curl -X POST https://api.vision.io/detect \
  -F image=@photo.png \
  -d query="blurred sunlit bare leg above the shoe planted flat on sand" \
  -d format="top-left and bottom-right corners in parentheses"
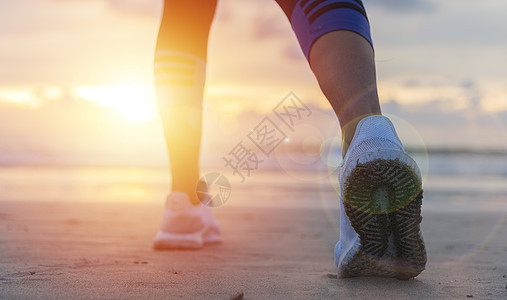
top-left (154, 0), bottom-right (217, 204)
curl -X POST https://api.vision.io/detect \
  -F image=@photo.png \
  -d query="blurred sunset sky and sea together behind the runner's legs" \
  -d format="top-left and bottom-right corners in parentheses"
top-left (0, 0), bottom-right (507, 204)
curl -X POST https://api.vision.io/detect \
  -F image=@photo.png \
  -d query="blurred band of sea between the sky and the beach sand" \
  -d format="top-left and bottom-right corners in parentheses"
top-left (0, 150), bottom-right (507, 211)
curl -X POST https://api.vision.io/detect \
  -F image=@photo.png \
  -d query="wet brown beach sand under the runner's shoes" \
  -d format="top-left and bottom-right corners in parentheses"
top-left (0, 192), bottom-right (507, 299)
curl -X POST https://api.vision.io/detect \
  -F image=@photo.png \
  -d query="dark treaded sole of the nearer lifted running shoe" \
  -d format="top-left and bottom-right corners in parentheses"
top-left (342, 150), bottom-right (426, 279)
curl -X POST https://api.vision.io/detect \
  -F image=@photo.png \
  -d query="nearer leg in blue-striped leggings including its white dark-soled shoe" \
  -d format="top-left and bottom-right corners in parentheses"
top-left (278, 0), bottom-right (426, 279)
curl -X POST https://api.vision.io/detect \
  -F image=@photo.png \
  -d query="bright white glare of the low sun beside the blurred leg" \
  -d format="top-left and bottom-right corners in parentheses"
top-left (75, 85), bottom-right (156, 122)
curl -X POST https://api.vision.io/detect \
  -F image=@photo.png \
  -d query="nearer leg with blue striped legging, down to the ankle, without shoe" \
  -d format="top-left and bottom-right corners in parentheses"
top-left (277, 0), bottom-right (381, 155)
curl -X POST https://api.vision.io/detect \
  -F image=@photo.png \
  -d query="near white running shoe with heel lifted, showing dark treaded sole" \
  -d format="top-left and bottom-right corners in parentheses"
top-left (335, 115), bottom-right (426, 279)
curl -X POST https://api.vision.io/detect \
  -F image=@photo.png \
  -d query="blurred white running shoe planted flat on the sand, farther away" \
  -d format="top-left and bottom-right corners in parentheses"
top-left (153, 192), bottom-right (221, 249)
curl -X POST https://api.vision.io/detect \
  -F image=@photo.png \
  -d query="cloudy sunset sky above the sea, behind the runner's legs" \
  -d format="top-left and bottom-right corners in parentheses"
top-left (0, 0), bottom-right (507, 165)
